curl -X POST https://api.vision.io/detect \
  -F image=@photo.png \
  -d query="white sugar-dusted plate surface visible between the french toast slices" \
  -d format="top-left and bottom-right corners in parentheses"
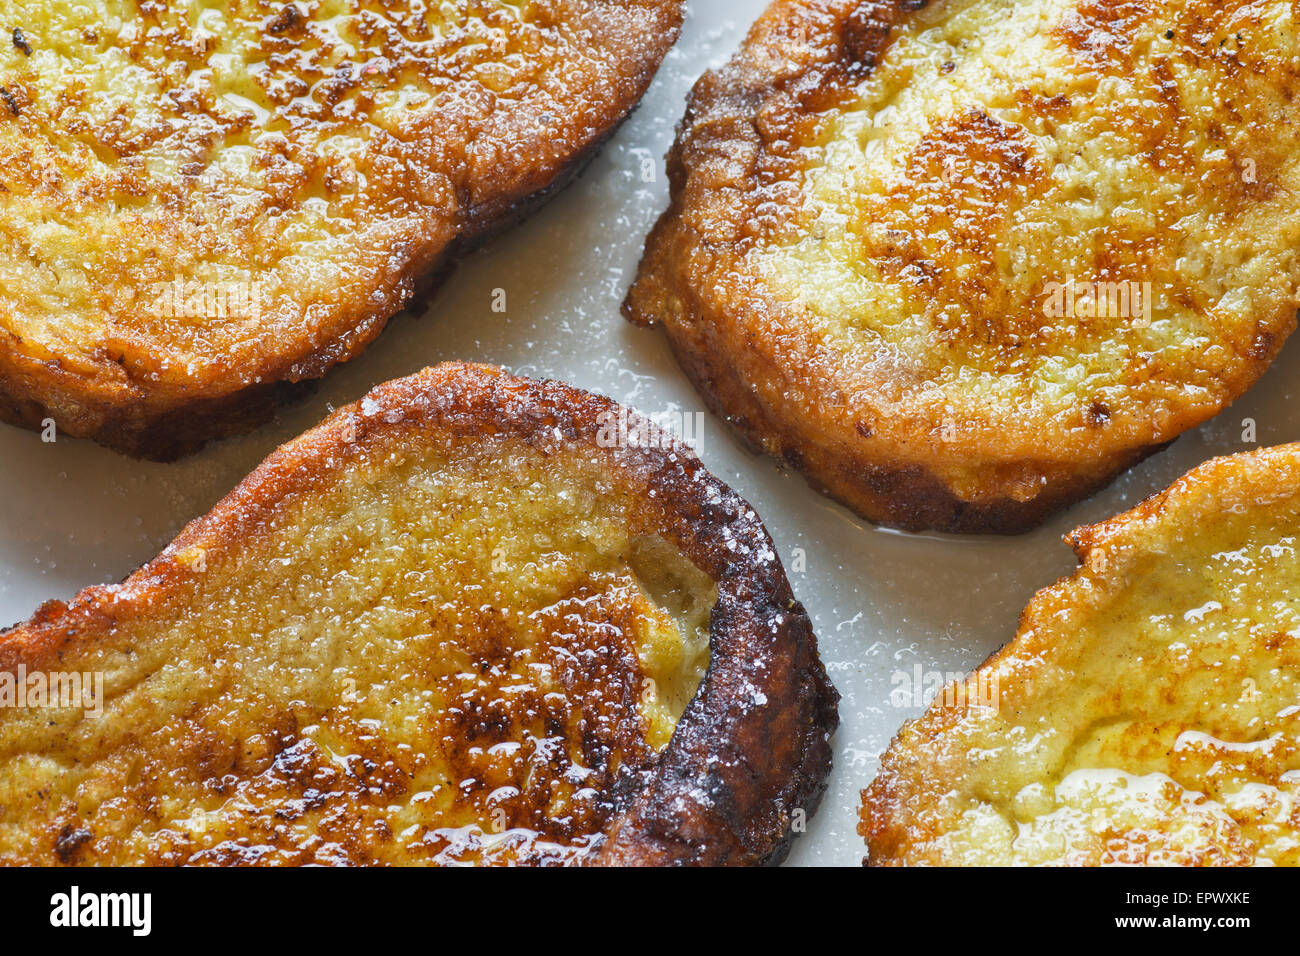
top-left (0, 0), bottom-right (1300, 865)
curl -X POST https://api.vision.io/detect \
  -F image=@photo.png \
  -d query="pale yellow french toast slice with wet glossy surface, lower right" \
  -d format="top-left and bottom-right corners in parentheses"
top-left (861, 445), bottom-right (1300, 865)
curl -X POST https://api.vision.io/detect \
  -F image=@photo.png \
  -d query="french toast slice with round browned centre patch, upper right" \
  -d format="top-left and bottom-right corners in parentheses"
top-left (625, 0), bottom-right (1300, 532)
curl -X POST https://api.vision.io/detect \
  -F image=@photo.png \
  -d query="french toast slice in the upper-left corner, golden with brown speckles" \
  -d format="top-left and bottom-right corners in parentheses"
top-left (0, 0), bottom-right (683, 459)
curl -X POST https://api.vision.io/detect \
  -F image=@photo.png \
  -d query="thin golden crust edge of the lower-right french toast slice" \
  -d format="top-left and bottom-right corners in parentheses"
top-left (858, 442), bottom-right (1300, 866)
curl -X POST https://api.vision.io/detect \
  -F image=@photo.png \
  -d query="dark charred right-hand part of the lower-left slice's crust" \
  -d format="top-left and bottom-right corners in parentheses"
top-left (372, 364), bottom-right (839, 865)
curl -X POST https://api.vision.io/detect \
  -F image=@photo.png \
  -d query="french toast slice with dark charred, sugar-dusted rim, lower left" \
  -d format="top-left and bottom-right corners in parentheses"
top-left (0, 364), bottom-right (837, 865)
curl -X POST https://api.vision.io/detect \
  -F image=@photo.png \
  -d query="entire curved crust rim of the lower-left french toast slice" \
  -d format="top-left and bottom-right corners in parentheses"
top-left (0, 363), bottom-right (839, 865)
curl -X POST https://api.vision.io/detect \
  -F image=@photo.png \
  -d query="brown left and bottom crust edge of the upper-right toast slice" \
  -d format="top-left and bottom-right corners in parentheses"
top-left (623, 0), bottom-right (1295, 535)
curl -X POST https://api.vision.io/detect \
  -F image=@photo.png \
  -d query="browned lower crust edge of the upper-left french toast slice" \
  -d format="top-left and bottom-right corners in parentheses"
top-left (0, 0), bottom-right (683, 462)
